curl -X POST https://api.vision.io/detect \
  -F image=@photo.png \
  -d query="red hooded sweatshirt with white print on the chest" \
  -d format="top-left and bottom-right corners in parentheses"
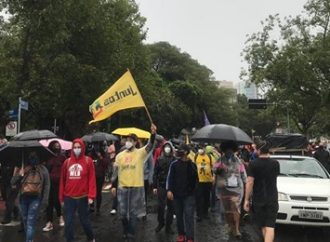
top-left (59, 139), bottom-right (96, 202)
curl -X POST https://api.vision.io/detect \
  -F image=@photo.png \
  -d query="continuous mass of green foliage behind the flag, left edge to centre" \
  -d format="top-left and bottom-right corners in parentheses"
top-left (0, 0), bottom-right (237, 138)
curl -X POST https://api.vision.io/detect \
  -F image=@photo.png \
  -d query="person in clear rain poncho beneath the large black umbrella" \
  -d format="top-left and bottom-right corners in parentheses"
top-left (214, 141), bottom-right (246, 238)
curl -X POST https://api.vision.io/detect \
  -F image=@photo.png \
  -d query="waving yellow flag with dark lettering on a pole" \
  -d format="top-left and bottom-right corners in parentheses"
top-left (89, 71), bottom-right (145, 124)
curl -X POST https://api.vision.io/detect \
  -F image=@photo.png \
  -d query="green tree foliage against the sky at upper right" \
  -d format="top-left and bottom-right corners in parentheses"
top-left (243, 0), bottom-right (330, 135)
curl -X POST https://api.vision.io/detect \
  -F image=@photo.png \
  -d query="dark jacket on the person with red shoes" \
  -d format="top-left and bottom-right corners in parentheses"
top-left (166, 159), bottom-right (198, 198)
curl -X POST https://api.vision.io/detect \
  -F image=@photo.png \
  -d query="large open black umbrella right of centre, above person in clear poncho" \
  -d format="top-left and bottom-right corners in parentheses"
top-left (192, 124), bottom-right (253, 144)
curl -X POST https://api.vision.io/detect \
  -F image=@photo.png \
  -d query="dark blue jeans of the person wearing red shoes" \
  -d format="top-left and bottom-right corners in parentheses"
top-left (174, 196), bottom-right (195, 240)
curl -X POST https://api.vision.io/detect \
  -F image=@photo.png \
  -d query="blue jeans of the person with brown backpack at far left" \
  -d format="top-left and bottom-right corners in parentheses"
top-left (19, 195), bottom-right (41, 242)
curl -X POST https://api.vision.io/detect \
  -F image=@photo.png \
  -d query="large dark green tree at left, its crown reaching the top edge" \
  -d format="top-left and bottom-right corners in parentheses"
top-left (0, 0), bottom-right (147, 137)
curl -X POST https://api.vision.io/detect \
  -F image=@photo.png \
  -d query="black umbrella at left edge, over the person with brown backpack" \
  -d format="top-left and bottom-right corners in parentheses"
top-left (0, 140), bottom-right (55, 164)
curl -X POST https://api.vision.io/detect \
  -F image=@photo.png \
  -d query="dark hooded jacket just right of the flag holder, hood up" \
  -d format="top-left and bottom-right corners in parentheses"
top-left (153, 142), bottom-right (176, 188)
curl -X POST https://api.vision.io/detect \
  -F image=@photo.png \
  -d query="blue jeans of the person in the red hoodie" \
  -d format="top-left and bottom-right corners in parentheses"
top-left (64, 197), bottom-right (94, 242)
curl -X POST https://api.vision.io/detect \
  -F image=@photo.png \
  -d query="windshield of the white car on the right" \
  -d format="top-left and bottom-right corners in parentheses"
top-left (275, 158), bottom-right (328, 178)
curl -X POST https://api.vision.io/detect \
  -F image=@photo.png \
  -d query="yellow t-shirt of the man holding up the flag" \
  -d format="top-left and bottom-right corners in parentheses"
top-left (114, 147), bottom-right (148, 187)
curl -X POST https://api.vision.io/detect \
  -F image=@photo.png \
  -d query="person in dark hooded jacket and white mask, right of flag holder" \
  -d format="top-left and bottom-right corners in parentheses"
top-left (153, 142), bottom-right (176, 233)
